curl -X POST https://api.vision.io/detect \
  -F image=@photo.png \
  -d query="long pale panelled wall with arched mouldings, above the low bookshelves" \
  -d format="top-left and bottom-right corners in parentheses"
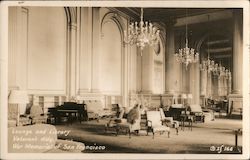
top-left (9, 7), bottom-right (164, 107)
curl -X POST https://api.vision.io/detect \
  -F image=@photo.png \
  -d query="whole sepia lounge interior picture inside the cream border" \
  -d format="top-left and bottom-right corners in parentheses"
top-left (1, 1), bottom-right (249, 158)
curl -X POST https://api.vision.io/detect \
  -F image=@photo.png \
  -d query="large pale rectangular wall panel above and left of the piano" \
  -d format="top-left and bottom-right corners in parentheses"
top-left (27, 7), bottom-right (67, 93)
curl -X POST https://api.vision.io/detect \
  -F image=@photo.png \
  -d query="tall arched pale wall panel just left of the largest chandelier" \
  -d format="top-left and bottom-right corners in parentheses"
top-left (100, 20), bottom-right (122, 95)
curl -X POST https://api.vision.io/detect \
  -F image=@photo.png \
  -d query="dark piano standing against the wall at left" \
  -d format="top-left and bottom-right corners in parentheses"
top-left (48, 102), bottom-right (87, 124)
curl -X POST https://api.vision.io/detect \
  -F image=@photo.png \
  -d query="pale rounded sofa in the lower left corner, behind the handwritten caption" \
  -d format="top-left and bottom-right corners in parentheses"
top-left (8, 124), bottom-right (85, 153)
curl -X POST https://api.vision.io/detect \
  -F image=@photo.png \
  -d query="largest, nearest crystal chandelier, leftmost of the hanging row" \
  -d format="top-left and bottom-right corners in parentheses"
top-left (124, 8), bottom-right (160, 56)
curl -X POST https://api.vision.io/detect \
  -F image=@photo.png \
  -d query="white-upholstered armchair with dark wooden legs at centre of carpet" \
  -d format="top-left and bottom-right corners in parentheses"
top-left (146, 111), bottom-right (170, 138)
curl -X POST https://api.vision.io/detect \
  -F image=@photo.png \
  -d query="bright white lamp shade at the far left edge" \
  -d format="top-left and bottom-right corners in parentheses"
top-left (9, 90), bottom-right (29, 104)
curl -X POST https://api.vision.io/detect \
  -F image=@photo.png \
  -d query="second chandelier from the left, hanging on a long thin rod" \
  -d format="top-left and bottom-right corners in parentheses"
top-left (175, 9), bottom-right (199, 69)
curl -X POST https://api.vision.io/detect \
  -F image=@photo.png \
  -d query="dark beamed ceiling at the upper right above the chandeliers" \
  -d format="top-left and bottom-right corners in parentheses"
top-left (116, 7), bottom-right (236, 68)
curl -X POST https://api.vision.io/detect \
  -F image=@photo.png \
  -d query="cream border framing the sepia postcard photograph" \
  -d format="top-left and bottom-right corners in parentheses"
top-left (0, 0), bottom-right (250, 159)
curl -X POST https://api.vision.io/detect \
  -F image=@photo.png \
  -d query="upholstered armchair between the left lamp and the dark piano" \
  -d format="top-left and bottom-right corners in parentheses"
top-left (30, 105), bottom-right (48, 124)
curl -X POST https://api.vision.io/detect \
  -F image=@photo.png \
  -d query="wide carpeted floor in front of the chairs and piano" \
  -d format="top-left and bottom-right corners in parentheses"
top-left (56, 119), bottom-right (242, 154)
